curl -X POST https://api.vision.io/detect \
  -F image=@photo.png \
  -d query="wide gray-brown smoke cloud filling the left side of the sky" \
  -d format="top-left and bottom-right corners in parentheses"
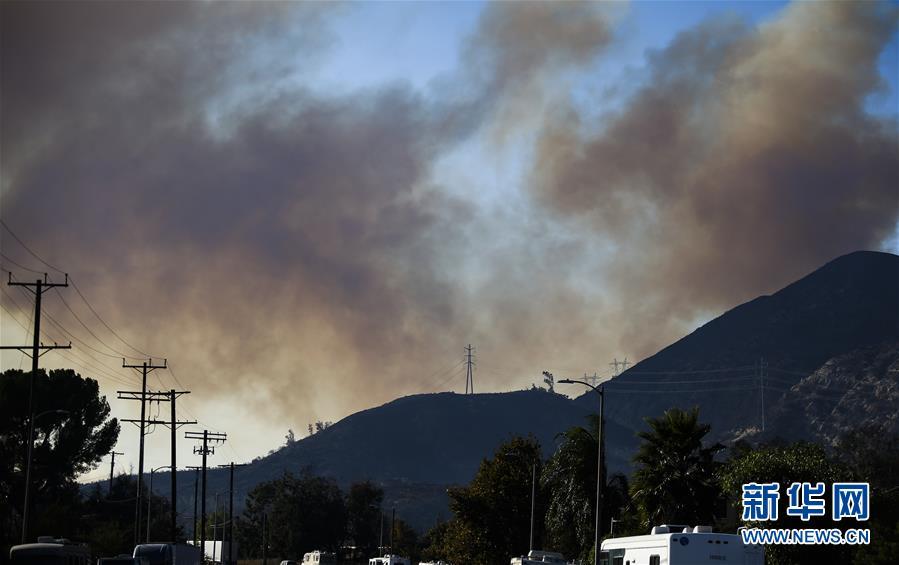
top-left (2, 2), bottom-right (608, 427)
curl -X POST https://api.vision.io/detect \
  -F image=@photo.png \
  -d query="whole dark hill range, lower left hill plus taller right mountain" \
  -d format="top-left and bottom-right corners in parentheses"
top-left (160, 252), bottom-right (899, 529)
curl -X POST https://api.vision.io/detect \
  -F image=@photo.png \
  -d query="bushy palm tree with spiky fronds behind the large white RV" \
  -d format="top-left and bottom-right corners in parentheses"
top-left (631, 407), bottom-right (723, 527)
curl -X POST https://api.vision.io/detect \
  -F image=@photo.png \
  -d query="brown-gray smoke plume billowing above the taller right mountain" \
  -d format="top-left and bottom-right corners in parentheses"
top-left (532, 2), bottom-right (899, 356)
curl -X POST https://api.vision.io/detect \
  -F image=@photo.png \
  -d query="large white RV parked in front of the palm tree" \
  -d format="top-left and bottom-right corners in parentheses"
top-left (599, 526), bottom-right (765, 565)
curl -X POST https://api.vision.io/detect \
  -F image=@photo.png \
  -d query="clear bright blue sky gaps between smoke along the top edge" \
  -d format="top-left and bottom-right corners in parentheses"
top-left (316, 0), bottom-right (899, 114)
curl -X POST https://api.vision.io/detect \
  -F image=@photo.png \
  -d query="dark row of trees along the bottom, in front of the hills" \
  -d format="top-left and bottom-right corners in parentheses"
top-left (0, 369), bottom-right (899, 565)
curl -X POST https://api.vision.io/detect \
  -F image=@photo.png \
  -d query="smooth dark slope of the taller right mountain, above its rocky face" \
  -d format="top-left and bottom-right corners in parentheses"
top-left (592, 252), bottom-right (899, 452)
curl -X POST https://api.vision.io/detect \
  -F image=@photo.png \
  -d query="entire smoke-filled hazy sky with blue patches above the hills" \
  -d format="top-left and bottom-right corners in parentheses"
top-left (0, 2), bottom-right (899, 484)
